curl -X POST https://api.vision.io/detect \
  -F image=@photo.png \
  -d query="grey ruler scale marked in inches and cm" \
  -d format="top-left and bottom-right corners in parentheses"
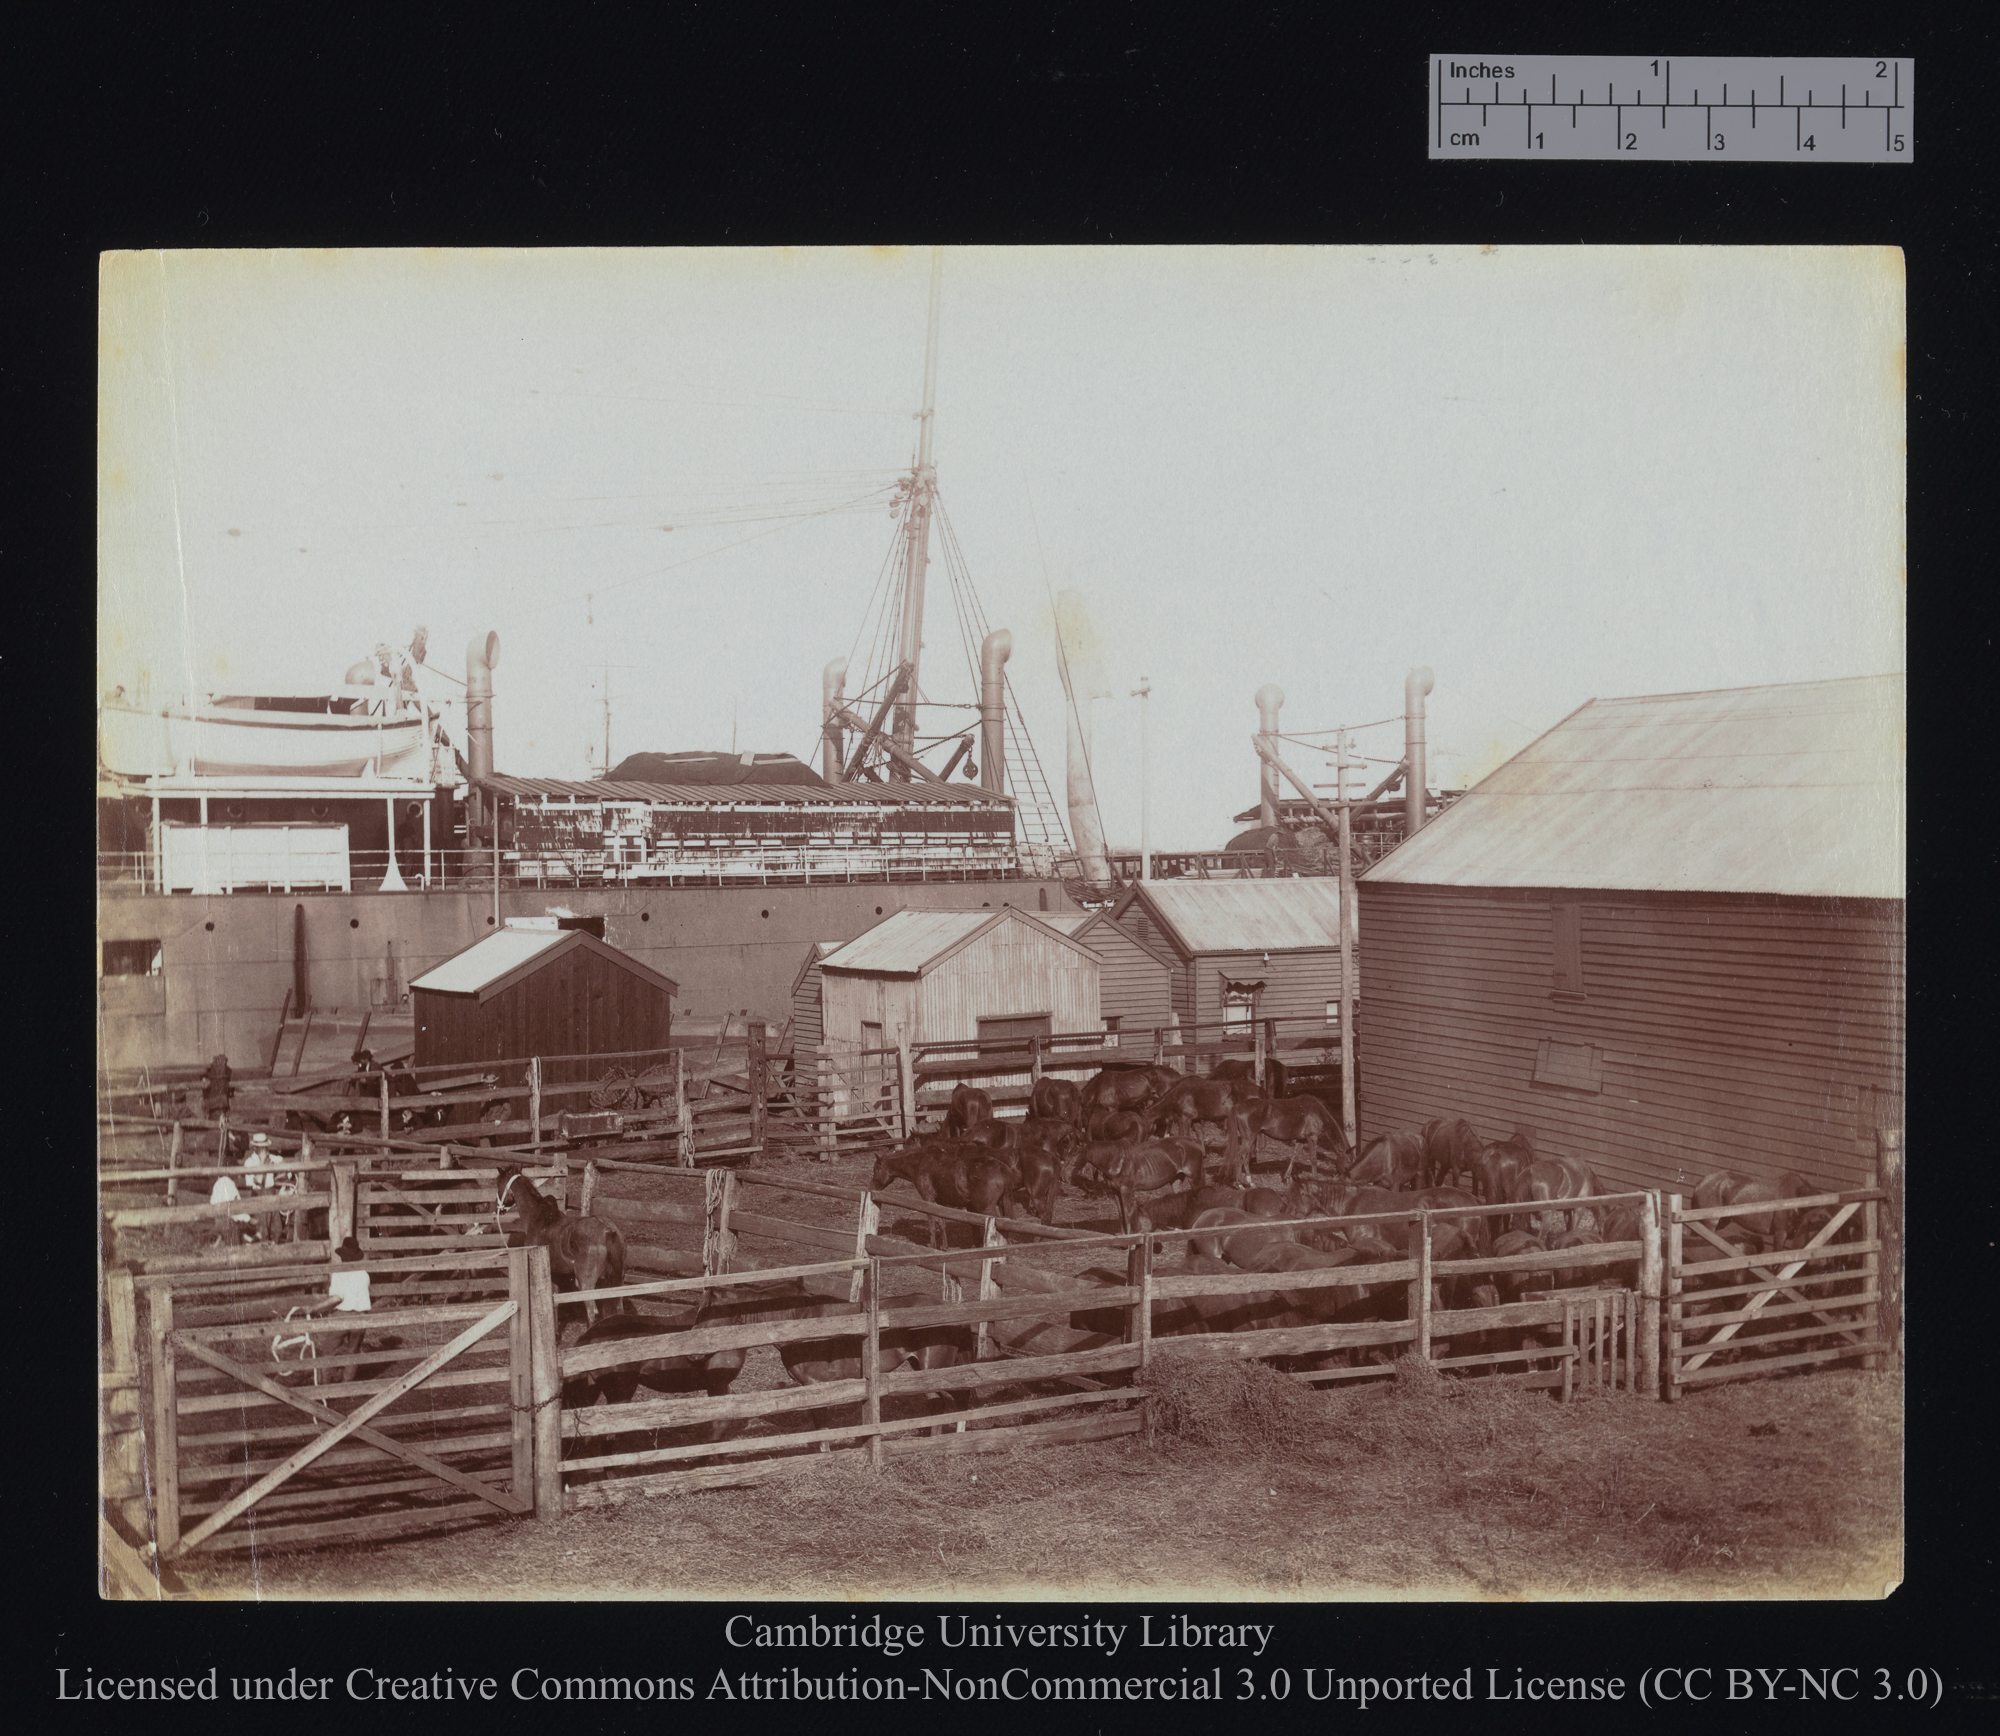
top-left (1428, 54), bottom-right (1916, 162)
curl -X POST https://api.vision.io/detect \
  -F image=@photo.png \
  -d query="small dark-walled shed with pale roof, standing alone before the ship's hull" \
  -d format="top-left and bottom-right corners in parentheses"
top-left (410, 926), bottom-right (676, 1084)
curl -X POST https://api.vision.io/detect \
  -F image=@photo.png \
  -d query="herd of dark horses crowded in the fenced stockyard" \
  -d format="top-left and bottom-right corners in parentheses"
top-left (386, 1064), bottom-right (1856, 1476)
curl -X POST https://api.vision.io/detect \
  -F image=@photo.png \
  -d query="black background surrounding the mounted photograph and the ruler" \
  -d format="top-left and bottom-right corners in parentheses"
top-left (23, 4), bottom-right (2000, 1730)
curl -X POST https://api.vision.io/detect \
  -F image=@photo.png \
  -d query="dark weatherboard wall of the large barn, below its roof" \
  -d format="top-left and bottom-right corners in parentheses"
top-left (1358, 882), bottom-right (1904, 1190)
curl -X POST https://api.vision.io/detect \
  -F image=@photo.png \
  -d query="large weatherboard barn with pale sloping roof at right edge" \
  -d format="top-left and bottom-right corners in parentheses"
top-left (1358, 676), bottom-right (1904, 1188)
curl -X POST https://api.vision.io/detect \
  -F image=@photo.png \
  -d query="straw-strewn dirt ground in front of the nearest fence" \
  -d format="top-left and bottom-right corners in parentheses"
top-left (184, 1354), bottom-right (1902, 1600)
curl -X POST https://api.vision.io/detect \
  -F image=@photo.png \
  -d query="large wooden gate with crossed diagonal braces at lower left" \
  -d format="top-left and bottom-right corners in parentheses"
top-left (148, 1248), bottom-right (548, 1560)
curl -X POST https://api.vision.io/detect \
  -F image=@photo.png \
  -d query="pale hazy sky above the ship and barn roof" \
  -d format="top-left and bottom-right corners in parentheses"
top-left (98, 246), bottom-right (1904, 850)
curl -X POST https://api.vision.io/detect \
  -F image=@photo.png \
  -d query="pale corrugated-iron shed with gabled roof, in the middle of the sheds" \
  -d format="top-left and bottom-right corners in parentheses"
top-left (820, 906), bottom-right (1102, 1050)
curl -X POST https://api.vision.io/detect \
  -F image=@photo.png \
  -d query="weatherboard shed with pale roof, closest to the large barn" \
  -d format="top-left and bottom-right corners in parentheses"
top-left (1104, 876), bottom-right (1360, 1040)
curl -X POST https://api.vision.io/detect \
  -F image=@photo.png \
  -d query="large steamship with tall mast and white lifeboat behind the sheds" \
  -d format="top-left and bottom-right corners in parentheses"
top-left (98, 254), bottom-right (1080, 1084)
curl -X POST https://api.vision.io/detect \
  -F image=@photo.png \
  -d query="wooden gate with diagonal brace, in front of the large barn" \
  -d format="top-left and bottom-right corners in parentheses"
top-left (1664, 1188), bottom-right (1890, 1400)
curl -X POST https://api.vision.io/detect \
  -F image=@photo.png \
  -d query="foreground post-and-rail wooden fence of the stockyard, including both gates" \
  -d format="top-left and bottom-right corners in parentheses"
top-left (100, 1160), bottom-right (1888, 1596)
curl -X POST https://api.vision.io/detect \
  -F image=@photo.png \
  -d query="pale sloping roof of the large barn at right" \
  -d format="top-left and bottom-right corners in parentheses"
top-left (1362, 676), bottom-right (1904, 898)
